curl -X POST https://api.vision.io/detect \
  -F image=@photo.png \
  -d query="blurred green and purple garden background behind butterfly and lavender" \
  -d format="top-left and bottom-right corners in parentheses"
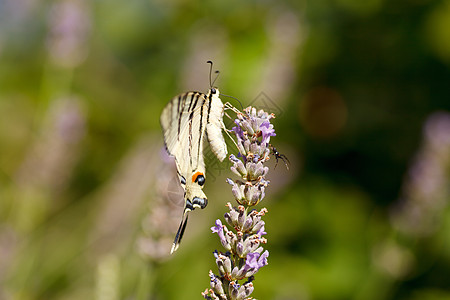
top-left (0, 0), bottom-right (450, 300)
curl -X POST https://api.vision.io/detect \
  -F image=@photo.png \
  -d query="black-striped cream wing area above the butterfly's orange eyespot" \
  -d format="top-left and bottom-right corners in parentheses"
top-left (161, 92), bottom-right (208, 179)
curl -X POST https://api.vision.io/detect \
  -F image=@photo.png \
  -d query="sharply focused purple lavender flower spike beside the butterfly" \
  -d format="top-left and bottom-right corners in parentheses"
top-left (202, 107), bottom-right (276, 300)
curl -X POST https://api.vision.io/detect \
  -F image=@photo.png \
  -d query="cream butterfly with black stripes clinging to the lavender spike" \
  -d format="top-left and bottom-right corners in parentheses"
top-left (160, 69), bottom-right (228, 253)
